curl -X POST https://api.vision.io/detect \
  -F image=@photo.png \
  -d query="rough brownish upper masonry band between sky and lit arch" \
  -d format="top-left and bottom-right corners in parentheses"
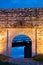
top-left (0, 8), bottom-right (43, 28)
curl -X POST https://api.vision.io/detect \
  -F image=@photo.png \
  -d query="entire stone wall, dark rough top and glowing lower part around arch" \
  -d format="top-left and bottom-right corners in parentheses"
top-left (0, 8), bottom-right (43, 55)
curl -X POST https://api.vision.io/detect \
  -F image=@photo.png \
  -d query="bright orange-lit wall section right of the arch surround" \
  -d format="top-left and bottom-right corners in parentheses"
top-left (37, 27), bottom-right (43, 54)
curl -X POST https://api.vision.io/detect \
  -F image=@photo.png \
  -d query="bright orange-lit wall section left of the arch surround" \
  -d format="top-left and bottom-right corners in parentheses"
top-left (0, 29), bottom-right (6, 54)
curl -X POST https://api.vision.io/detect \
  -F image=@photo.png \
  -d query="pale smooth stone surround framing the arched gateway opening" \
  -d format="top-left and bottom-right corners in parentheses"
top-left (8, 28), bottom-right (35, 56)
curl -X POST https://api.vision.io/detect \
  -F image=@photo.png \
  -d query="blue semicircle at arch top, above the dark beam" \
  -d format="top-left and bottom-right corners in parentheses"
top-left (12, 34), bottom-right (31, 43)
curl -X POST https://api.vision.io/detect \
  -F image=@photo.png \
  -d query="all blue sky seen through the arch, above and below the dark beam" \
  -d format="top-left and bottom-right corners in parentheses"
top-left (11, 34), bottom-right (31, 58)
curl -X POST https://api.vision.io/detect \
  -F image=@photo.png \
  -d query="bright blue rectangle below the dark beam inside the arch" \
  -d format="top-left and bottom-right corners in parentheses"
top-left (11, 46), bottom-right (25, 58)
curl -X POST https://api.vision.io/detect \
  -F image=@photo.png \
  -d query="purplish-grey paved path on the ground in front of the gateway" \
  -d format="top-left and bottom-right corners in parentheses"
top-left (4, 58), bottom-right (43, 65)
